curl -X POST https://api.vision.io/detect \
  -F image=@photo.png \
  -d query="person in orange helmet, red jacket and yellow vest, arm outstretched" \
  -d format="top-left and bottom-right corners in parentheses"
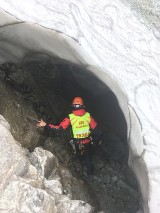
top-left (37, 97), bottom-right (100, 181)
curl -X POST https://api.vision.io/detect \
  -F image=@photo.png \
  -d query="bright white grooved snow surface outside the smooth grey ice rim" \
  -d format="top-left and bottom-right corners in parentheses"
top-left (0, 0), bottom-right (160, 213)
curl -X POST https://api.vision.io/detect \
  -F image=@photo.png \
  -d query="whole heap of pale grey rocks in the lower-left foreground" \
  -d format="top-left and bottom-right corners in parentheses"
top-left (0, 116), bottom-right (93, 213)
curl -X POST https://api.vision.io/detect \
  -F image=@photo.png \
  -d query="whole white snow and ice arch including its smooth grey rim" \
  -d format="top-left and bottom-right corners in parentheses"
top-left (0, 0), bottom-right (160, 213)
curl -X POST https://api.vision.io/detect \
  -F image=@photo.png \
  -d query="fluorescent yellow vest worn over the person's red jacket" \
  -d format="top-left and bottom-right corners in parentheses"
top-left (69, 112), bottom-right (91, 138)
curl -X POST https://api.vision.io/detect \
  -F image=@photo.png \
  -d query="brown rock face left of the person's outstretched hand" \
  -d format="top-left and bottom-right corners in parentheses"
top-left (0, 82), bottom-right (39, 150)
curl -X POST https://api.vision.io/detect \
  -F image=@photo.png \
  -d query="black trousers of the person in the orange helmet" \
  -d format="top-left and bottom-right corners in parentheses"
top-left (75, 141), bottom-right (94, 176)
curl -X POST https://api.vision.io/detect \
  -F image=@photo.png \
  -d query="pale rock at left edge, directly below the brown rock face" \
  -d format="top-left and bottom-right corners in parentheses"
top-left (0, 116), bottom-right (28, 196)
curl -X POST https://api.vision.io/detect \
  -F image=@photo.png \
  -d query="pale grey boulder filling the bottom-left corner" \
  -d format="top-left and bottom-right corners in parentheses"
top-left (0, 181), bottom-right (56, 213)
